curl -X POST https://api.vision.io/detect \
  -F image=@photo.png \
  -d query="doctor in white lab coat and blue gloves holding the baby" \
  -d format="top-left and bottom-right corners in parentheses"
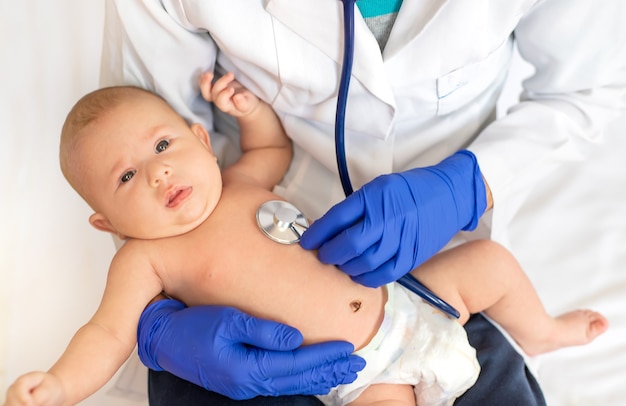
top-left (102, 0), bottom-right (626, 405)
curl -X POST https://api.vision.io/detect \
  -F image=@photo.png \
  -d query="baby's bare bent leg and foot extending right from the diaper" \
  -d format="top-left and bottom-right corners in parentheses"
top-left (412, 240), bottom-right (608, 355)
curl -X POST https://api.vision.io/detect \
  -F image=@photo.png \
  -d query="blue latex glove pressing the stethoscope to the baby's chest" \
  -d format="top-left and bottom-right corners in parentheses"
top-left (300, 151), bottom-right (487, 287)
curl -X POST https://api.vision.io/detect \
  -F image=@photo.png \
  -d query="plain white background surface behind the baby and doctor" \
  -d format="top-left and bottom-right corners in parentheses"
top-left (0, 0), bottom-right (626, 406)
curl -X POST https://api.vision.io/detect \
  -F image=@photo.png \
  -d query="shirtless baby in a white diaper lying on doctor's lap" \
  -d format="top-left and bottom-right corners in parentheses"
top-left (6, 73), bottom-right (608, 405)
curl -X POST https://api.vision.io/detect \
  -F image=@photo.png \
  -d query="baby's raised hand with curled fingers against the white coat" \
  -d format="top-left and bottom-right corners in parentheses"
top-left (200, 72), bottom-right (260, 118)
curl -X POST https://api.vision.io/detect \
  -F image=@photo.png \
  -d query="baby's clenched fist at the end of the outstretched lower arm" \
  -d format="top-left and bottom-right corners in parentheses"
top-left (4, 372), bottom-right (65, 406)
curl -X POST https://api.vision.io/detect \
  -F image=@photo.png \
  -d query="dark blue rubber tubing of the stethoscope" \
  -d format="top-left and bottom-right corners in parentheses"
top-left (335, 0), bottom-right (460, 319)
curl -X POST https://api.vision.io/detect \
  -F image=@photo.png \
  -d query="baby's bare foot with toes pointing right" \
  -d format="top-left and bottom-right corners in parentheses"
top-left (522, 310), bottom-right (609, 356)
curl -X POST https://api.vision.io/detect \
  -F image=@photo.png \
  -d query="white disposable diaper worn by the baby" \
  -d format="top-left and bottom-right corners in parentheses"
top-left (318, 283), bottom-right (480, 406)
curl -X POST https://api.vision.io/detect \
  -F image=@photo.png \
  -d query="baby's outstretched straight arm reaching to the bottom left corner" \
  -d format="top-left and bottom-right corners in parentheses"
top-left (5, 248), bottom-right (162, 406)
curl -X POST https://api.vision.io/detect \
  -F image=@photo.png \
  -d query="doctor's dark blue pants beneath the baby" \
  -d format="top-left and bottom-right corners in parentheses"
top-left (148, 315), bottom-right (546, 406)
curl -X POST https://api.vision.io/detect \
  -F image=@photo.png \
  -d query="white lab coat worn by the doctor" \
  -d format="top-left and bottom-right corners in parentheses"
top-left (102, 0), bottom-right (626, 239)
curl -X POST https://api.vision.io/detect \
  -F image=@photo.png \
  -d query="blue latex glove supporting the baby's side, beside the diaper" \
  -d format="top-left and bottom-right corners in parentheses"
top-left (137, 299), bottom-right (365, 400)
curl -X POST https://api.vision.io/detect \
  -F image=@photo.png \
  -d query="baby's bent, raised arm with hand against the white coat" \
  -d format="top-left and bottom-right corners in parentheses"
top-left (200, 72), bottom-right (292, 189)
